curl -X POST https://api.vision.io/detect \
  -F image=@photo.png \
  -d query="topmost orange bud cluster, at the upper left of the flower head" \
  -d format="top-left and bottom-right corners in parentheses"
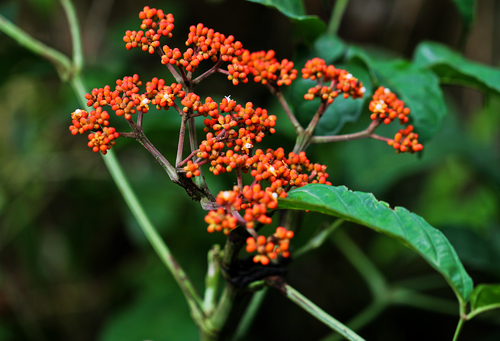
top-left (123, 6), bottom-right (174, 54)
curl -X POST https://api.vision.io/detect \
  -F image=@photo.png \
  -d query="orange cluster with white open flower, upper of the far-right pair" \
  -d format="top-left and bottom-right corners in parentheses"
top-left (368, 86), bottom-right (410, 124)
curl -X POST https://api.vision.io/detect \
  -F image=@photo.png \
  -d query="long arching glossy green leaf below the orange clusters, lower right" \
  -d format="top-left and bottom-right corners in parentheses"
top-left (279, 184), bottom-right (472, 303)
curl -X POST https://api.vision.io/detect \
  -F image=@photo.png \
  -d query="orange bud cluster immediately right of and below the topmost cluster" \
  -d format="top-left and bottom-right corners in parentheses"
top-left (161, 23), bottom-right (246, 74)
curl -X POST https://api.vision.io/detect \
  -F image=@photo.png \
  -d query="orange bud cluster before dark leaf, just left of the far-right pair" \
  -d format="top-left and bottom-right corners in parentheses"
top-left (302, 58), bottom-right (366, 99)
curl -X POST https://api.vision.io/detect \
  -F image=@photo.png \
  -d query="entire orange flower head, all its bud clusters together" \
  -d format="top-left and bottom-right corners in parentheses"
top-left (69, 6), bottom-right (430, 265)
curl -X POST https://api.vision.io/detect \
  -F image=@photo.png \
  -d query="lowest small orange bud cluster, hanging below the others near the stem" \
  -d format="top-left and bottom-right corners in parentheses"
top-left (246, 226), bottom-right (293, 265)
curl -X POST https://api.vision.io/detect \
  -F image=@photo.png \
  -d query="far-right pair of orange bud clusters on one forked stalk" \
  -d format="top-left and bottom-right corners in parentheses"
top-left (368, 86), bottom-right (424, 154)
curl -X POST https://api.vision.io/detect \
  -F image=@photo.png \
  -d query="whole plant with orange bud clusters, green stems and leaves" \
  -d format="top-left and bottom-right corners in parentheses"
top-left (2, 0), bottom-right (500, 340)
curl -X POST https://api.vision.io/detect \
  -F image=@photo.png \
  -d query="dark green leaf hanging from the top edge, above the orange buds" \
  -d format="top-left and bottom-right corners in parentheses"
top-left (247, 0), bottom-right (326, 42)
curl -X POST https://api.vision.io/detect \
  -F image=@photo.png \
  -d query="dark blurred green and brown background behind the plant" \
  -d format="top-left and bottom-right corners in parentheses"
top-left (0, 0), bottom-right (500, 341)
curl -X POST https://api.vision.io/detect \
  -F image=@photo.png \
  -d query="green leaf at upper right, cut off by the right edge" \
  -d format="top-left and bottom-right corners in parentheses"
top-left (413, 42), bottom-right (500, 94)
